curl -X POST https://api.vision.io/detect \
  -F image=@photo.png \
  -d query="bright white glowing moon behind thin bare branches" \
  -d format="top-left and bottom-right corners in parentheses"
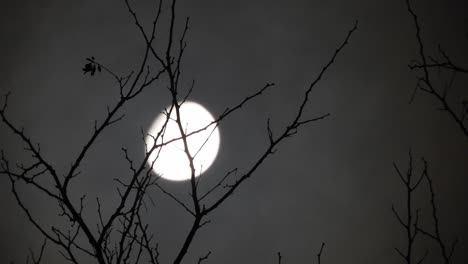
top-left (146, 101), bottom-right (220, 181)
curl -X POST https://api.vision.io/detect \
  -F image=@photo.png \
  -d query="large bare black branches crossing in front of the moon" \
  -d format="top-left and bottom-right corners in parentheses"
top-left (0, 0), bottom-right (357, 264)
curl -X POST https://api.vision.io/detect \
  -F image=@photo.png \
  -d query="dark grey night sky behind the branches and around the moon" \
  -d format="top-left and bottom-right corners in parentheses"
top-left (0, 0), bottom-right (468, 264)
